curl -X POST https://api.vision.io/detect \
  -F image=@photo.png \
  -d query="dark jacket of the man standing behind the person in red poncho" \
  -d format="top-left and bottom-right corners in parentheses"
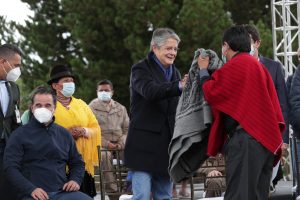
top-left (259, 56), bottom-right (289, 143)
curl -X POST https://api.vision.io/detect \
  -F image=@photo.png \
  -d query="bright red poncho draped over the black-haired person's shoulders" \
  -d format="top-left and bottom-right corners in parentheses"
top-left (203, 53), bottom-right (285, 159)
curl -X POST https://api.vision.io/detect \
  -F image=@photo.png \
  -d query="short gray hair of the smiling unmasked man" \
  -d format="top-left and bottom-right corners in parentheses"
top-left (150, 28), bottom-right (180, 51)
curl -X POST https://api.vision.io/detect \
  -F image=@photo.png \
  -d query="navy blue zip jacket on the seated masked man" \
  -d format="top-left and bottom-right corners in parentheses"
top-left (3, 118), bottom-right (84, 197)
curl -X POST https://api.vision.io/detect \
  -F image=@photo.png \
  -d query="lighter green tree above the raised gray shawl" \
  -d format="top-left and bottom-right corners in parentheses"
top-left (176, 0), bottom-right (232, 72)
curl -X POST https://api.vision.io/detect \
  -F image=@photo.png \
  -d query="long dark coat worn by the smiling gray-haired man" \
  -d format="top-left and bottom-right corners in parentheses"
top-left (125, 52), bottom-right (181, 175)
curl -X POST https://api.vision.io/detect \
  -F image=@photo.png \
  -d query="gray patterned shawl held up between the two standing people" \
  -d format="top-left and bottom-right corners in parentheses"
top-left (169, 49), bottom-right (222, 182)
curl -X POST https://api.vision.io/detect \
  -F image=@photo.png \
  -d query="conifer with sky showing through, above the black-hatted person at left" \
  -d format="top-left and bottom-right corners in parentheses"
top-left (17, 0), bottom-right (83, 108)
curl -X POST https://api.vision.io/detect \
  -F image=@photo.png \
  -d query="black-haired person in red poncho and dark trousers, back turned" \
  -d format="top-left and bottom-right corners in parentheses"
top-left (198, 26), bottom-right (285, 200)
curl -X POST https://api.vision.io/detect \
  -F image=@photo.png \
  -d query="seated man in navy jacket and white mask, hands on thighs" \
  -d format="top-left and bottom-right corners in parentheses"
top-left (4, 87), bottom-right (92, 200)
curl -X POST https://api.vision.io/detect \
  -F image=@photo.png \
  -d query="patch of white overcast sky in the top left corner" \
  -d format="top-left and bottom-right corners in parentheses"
top-left (0, 0), bottom-right (32, 24)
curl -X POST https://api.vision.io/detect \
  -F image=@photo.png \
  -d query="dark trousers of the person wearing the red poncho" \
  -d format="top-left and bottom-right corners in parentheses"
top-left (224, 129), bottom-right (274, 200)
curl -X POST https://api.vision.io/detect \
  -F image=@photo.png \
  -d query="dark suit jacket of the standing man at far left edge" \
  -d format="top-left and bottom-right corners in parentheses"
top-left (0, 81), bottom-right (21, 140)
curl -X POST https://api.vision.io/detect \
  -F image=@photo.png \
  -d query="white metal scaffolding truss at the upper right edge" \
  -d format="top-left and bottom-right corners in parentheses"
top-left (271, 0), bottom-right (300, 76)
